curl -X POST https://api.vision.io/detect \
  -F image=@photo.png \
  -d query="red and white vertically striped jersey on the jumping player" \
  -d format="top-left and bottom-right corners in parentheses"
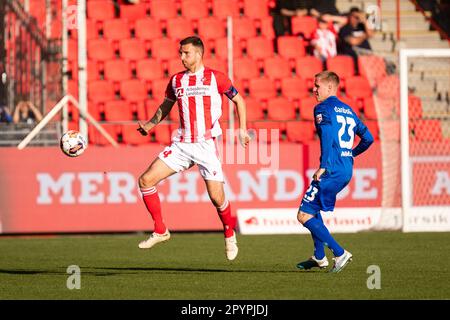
top-left (166, 67), bottom-right (233, 142)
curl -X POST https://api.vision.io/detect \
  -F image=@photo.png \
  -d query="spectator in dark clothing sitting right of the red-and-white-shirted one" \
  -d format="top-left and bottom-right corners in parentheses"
top-left (338, 7), bottom-right (373, 72)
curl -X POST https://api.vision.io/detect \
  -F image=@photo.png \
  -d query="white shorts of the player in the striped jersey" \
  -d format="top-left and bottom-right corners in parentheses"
top-left (159, 139), bottom-right (224, 182)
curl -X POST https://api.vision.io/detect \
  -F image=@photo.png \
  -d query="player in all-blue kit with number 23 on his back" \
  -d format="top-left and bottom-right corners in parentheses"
top-left (297, 71), bottom-right (373, 272)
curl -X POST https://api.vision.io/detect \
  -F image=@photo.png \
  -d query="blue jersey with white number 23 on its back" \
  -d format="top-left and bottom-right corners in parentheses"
top-left (314, 96), bottom-right (373, 178)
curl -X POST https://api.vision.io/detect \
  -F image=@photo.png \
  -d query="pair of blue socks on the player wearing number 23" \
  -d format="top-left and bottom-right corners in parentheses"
top-left (303, 213), bottom-right (344, 259)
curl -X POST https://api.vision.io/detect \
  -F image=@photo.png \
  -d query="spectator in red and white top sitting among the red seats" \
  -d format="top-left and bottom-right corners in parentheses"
top-left (311, 16), bottom-right (337, 63)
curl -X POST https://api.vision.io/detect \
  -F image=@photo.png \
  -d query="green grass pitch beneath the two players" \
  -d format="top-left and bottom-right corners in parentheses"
top-left (0, 232), bottom-right (450, 300)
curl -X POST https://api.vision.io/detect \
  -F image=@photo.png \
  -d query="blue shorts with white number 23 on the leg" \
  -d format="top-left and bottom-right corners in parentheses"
top-left (299, 174), bottom-right (351, 215)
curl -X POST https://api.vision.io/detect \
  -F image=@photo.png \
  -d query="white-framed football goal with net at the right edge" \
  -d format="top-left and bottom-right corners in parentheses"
top-left (399, 49), bottom-right (450, 232)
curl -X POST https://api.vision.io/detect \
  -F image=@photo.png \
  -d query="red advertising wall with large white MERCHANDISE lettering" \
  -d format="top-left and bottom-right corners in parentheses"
top-left (0, 142), bottom-right (382, 233)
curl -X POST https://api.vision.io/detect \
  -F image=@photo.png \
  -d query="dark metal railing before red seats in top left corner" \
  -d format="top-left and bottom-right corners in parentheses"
top-left (0, 0), bottom-right (62, 113)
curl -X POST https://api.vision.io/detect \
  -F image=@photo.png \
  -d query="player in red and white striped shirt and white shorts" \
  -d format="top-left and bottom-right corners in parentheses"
top-left (138, 36), bottom-right (250, 260)
